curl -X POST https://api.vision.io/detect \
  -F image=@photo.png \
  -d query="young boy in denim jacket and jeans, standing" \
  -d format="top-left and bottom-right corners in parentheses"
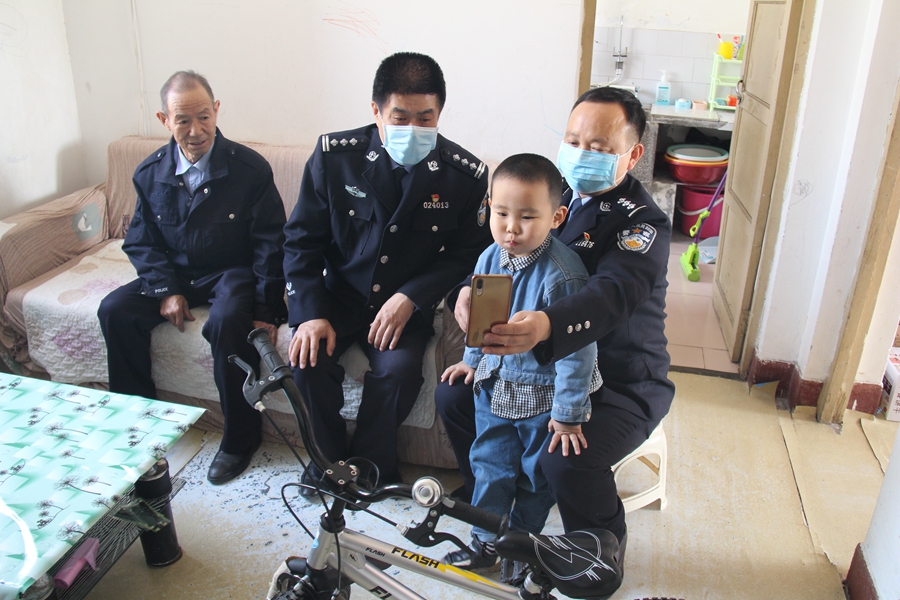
top-left (441, 154), bottom-right (601, 570)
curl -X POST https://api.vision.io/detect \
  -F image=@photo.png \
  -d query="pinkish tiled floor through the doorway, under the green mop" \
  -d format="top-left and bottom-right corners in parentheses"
top-left (666, 232), bottom-right (738, 374)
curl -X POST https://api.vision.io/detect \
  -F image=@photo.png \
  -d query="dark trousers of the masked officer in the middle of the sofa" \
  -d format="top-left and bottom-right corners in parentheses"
top-left (293, 311), bottom-right (434, 481)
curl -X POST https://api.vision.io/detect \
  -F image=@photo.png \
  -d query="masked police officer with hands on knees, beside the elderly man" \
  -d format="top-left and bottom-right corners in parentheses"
top-left (284, 52), bottom-right (491, 493)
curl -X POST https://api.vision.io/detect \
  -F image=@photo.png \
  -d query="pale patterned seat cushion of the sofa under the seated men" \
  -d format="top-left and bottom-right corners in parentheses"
top-left (19, 240), bottom-right (443, 428)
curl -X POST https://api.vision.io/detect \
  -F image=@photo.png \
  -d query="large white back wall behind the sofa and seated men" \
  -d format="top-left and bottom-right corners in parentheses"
top-left (64, 0), bottom-right (583, 181)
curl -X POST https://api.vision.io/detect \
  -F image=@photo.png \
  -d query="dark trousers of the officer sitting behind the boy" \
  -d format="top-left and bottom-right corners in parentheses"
top-left (434, 381), bottom-right (656, 540)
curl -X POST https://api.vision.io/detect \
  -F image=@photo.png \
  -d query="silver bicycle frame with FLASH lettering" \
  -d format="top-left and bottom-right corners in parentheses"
top-left (306, 528), bottom-right (519, 600)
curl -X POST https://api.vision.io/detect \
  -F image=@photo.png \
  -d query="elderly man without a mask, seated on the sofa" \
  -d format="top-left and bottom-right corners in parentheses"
top-left (98, 71), bottom-right (287, 484)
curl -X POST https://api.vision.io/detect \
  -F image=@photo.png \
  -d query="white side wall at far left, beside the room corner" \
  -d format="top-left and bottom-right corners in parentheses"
top-left (0, 0), bottom-right (87, 218)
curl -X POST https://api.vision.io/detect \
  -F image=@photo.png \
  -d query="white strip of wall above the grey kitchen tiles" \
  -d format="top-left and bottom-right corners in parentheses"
top-left (596, 0), bottom-right (750, 34)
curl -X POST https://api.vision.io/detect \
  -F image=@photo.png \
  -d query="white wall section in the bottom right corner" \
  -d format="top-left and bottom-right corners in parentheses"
top-left (862, 424), bottom-right (900, 600)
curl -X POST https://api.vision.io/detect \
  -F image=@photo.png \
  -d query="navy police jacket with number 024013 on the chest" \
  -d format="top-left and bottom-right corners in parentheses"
top-left (284, 124), bottom-right (491, 335)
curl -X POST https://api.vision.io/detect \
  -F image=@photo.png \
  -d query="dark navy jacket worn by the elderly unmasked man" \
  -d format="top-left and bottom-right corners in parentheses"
top-left (122, 129), bottom-right (286, 324)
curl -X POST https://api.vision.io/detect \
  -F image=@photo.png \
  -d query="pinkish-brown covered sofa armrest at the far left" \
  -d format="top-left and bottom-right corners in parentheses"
top-left (0, 183), bottom-right (109, 348)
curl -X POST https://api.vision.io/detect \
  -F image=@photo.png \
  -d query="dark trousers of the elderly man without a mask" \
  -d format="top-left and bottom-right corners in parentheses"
top-left (97, 267), bottom-right (261, 453)
